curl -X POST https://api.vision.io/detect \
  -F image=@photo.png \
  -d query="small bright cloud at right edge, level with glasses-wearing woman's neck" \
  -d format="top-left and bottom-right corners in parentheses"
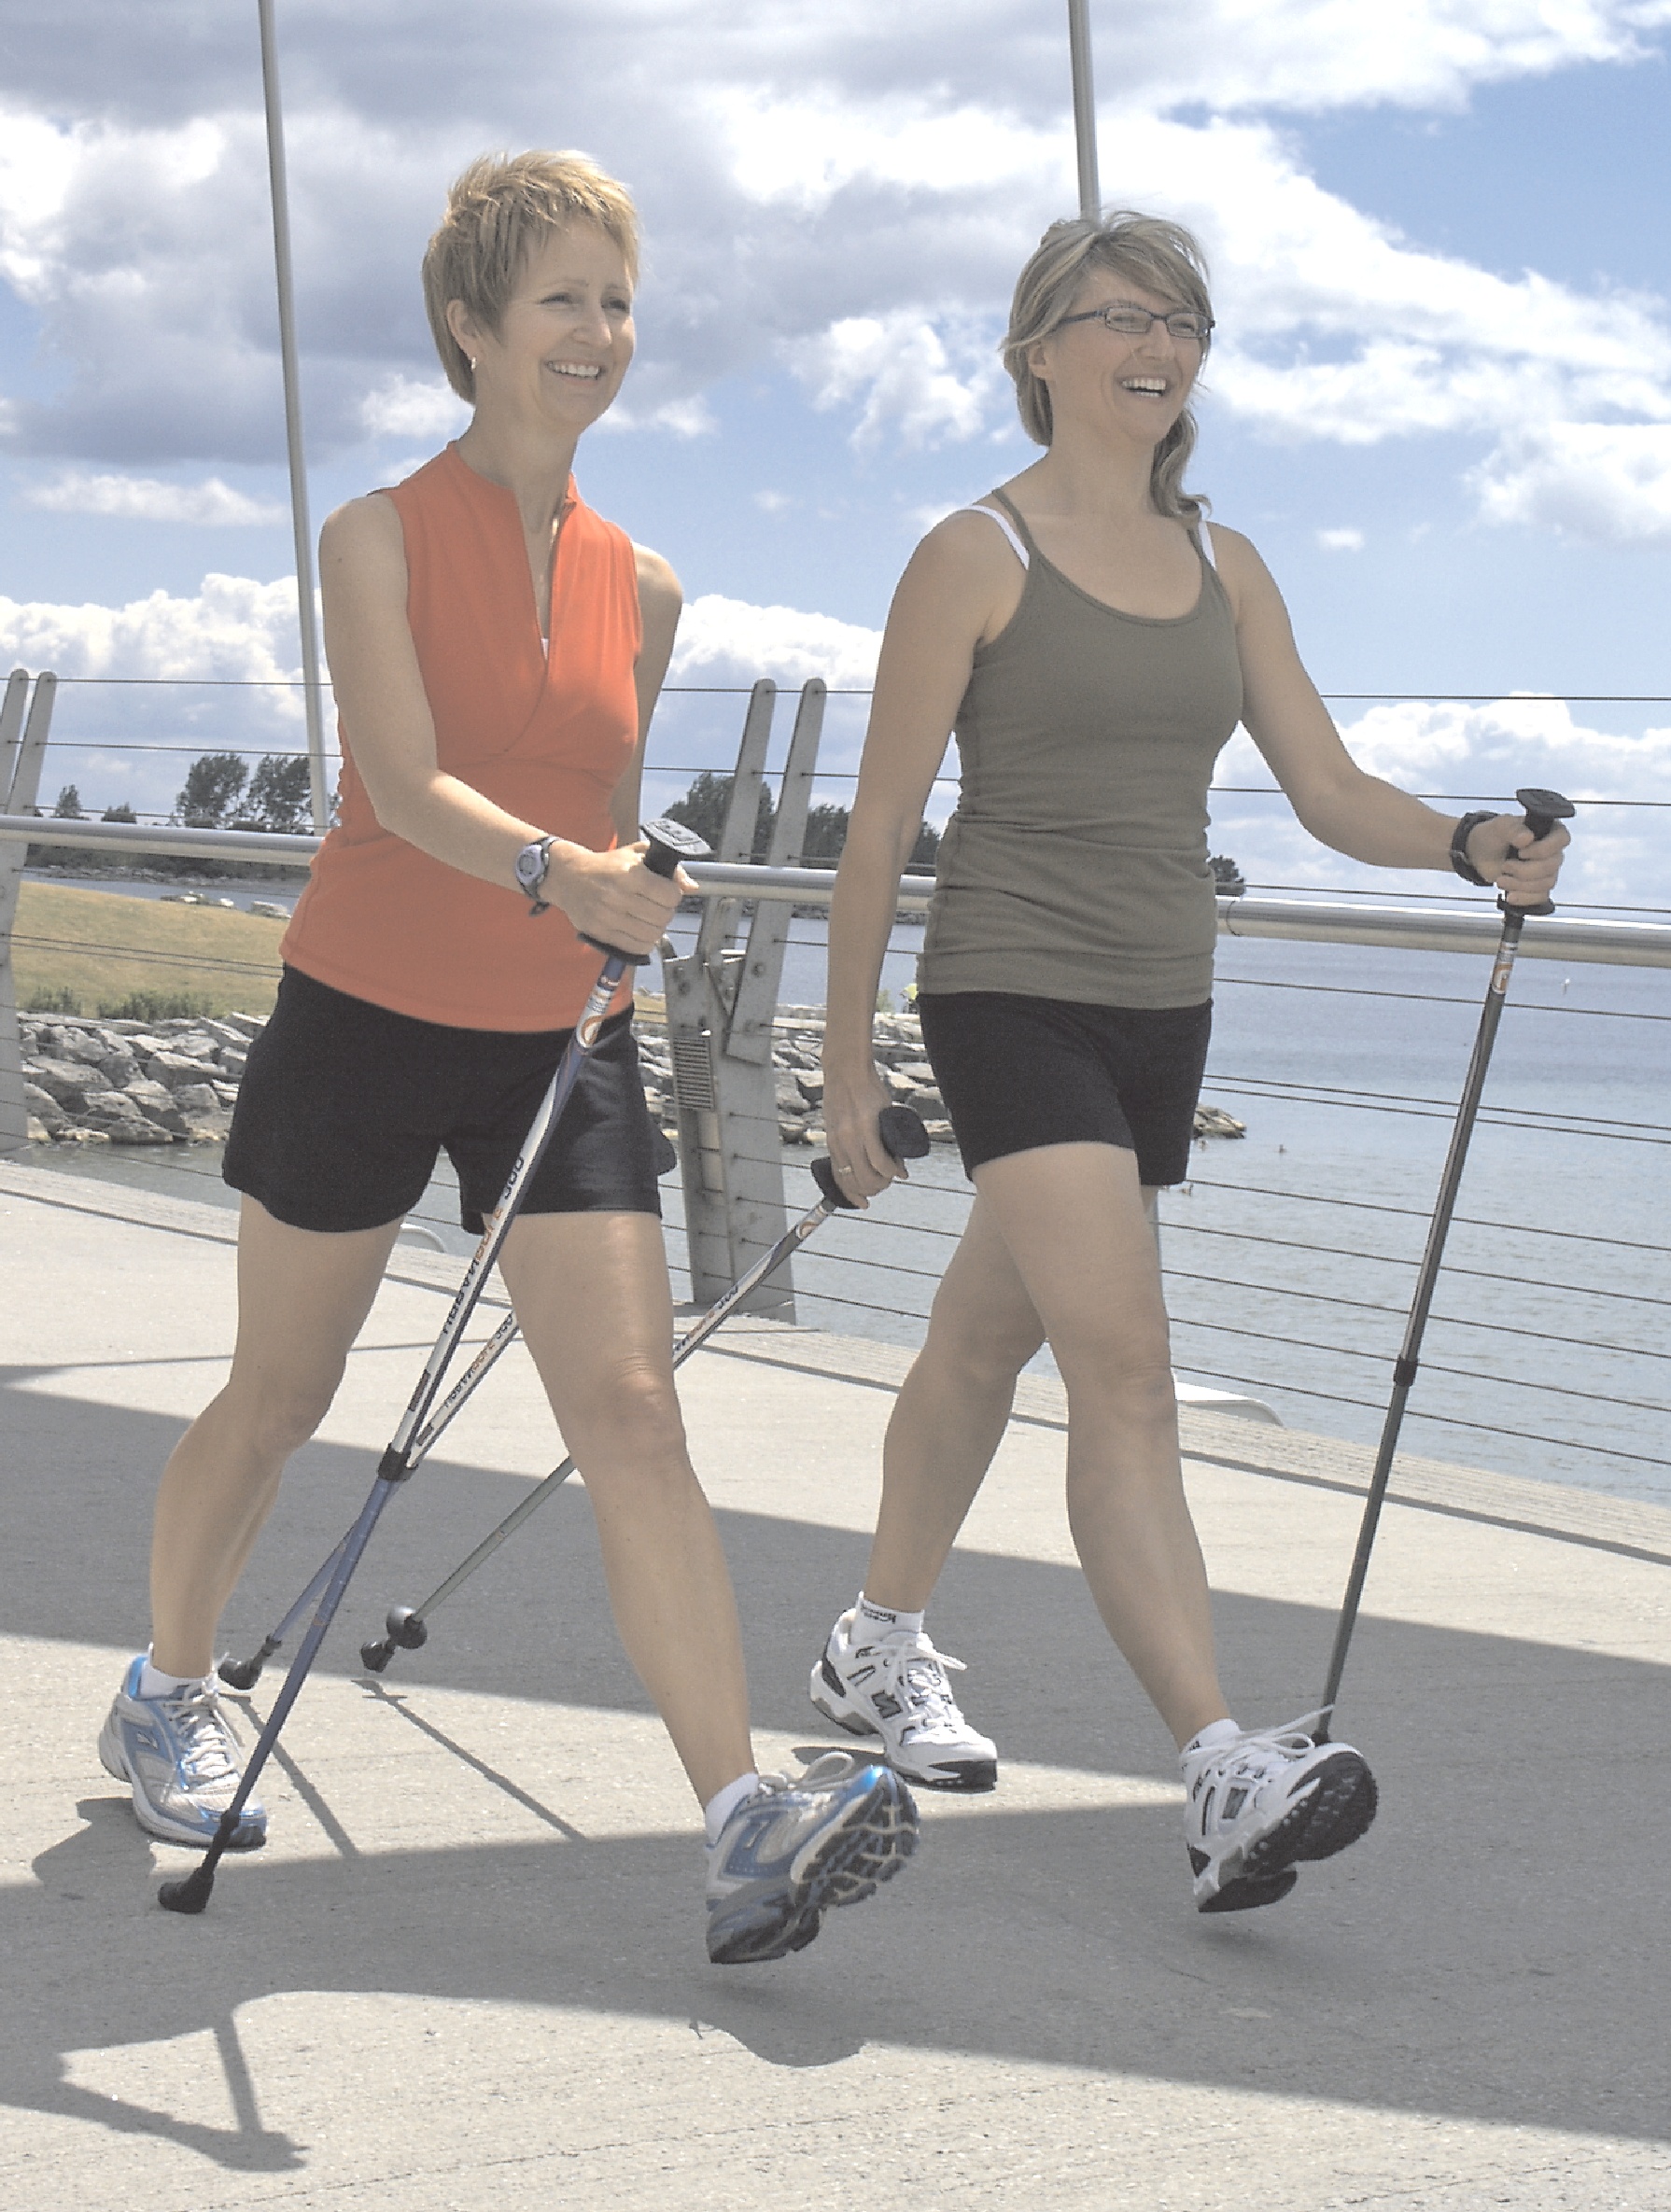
top-left (1472, 423), bottom-right (1671, 544)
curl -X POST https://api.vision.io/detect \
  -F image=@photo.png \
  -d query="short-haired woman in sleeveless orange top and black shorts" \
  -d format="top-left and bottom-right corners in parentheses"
top-left (100, 153), bottom-right (917, 1965)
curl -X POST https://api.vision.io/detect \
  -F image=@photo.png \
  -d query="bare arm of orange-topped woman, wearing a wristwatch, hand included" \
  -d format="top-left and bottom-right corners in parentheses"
top-left (318, 496), bottom-right (677, 951)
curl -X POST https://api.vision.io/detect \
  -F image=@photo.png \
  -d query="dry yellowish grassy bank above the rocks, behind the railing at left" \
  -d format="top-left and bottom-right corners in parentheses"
top-left (11, 883), bottom-right (283, 1020)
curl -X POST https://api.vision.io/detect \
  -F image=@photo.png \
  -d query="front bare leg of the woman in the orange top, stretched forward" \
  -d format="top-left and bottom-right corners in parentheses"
top-left (502, 1214), bottom-right (754, 1803)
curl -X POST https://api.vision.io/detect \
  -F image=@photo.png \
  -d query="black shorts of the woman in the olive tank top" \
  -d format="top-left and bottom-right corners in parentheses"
top-left (917, 991), bottom-right (1213, 1183)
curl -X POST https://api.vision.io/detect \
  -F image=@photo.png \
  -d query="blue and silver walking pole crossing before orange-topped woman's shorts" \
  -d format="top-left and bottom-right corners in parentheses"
top-left (157, 820), bottom-right (709, 1913)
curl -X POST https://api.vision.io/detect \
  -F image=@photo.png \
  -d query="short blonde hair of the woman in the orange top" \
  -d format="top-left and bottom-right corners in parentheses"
top-left (423, 153), bottom-right (638, 402)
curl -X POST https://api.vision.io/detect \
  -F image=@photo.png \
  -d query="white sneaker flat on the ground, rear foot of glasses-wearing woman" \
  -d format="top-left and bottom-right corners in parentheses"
top-left (807, 1613), bottom-right (998, 1792)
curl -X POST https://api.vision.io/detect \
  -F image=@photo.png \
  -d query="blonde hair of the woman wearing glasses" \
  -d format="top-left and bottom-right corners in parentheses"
top-left (1001, 208), bottom-right (1213, 522)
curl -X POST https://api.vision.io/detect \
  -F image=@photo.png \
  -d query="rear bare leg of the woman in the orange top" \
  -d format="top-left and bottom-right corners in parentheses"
top-left (150, 1199), bottom-right (400, 1674)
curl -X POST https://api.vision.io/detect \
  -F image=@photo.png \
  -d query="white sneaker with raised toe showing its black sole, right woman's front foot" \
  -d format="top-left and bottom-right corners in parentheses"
top-left (1177, 1712), bottom-right (1377, 1913)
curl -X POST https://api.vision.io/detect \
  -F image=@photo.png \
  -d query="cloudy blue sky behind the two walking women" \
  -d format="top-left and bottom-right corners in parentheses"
top-left (0, 0), bottom-right (1671, 903)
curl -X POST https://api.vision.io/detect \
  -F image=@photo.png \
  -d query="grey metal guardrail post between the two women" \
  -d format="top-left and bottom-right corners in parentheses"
top-left (662, 681), bottom-right (825, 1321)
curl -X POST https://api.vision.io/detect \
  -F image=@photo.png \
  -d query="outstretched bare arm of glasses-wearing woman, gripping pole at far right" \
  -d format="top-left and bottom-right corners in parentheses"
top-left (1213, 526), bottom-right (1569, 904)
